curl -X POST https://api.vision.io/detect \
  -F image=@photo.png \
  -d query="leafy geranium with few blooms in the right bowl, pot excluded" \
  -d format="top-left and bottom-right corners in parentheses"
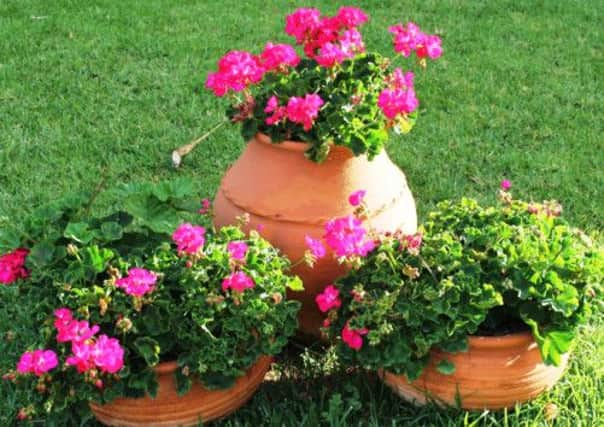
top-left (316, 181), bottom-right (604, 380)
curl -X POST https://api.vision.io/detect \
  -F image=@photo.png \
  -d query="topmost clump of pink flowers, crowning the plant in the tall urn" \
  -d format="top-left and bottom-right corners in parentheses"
top-left (285, 7), bottom-right (368, 67)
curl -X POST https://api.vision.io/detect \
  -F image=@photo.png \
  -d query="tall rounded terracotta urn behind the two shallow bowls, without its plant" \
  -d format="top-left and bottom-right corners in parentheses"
top-left (214, 134), bottom-right (417, 336)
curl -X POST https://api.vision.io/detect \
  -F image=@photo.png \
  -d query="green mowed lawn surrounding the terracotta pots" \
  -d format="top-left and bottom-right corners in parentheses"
top-left (0, 0), bottom-right (604, 427)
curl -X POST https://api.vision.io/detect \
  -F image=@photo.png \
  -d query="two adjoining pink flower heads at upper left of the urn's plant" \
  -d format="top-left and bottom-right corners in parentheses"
top-left (206, 42), bottom-right (300, 96)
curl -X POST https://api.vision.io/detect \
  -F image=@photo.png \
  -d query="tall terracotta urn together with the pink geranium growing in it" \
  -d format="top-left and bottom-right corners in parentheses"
top-left (206, 7), bottom-right (442, 334)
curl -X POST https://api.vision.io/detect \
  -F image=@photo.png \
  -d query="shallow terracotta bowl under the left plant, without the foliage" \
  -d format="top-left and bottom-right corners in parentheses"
top-left (90, 356), bottom-right (272, 427)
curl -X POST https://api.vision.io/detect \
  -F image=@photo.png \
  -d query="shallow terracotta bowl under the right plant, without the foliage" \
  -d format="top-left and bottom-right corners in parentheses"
top-left (380, 332), bottom-right (568, 410)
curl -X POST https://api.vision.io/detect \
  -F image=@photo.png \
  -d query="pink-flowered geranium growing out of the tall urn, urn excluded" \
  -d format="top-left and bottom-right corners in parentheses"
top-left (205, 7), bottom-right (442, 162)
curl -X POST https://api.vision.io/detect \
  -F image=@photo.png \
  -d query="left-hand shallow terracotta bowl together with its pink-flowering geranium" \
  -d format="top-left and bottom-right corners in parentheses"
top-left (0, 182), bottom-right (301, 426)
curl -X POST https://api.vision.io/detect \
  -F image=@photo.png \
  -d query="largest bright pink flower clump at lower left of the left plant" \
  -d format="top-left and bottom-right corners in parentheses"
top-left (54, 308), bottom-right (124, 374)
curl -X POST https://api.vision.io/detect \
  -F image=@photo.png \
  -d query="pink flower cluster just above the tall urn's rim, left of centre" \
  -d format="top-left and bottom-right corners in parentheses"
top-left (264, 93), bottom-right (324, 131)
